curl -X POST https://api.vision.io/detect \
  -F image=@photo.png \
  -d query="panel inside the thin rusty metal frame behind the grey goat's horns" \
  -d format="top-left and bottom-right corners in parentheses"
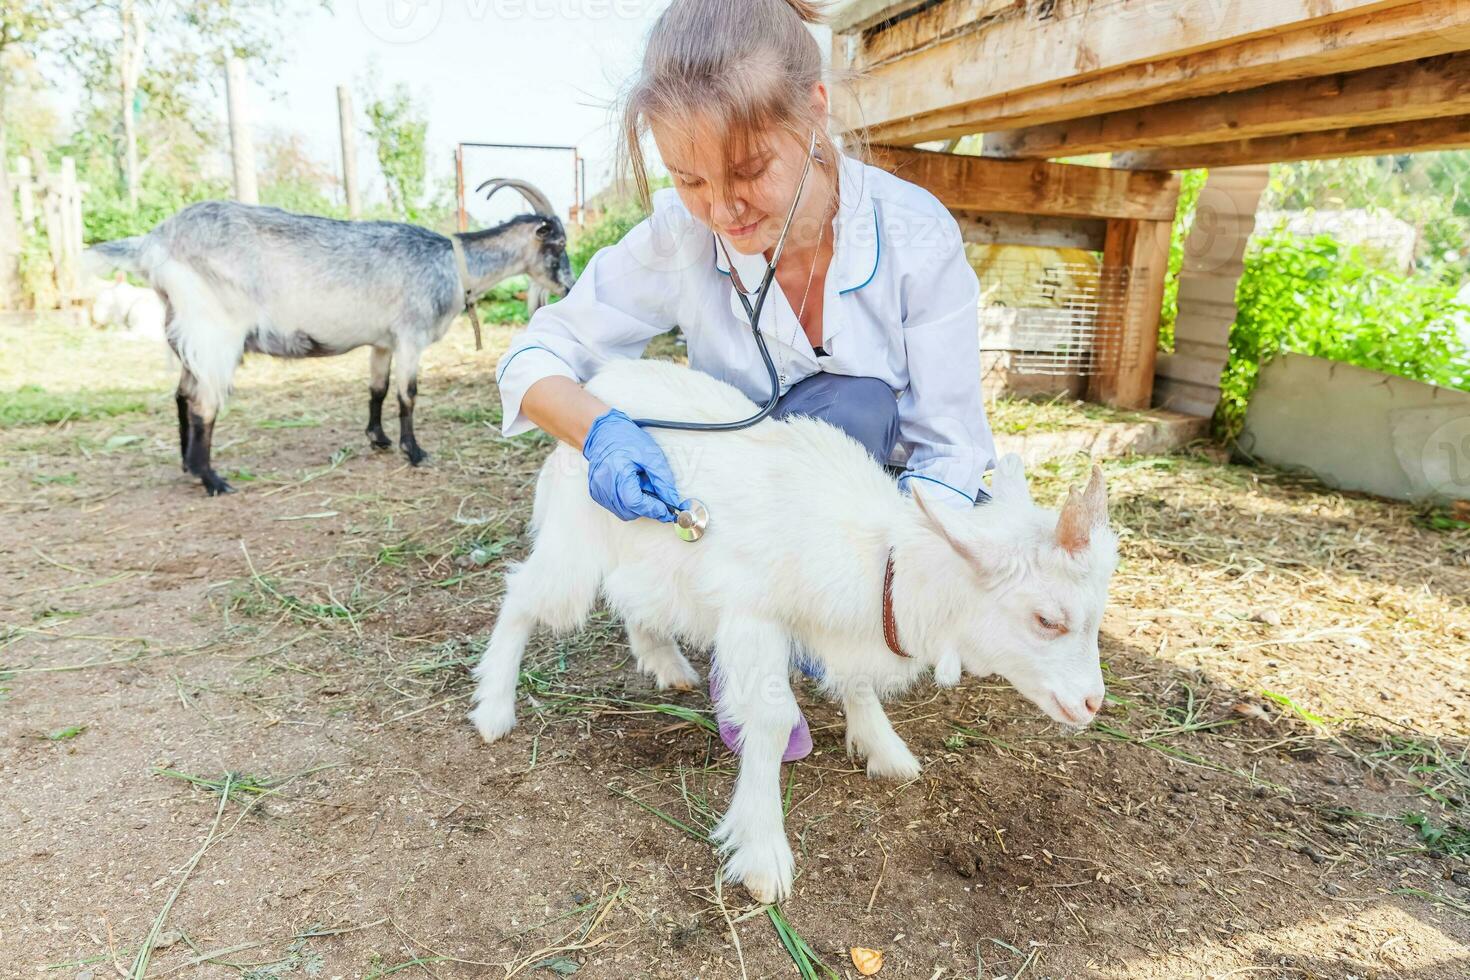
top-left (459, 143), bottom-right (582, 228)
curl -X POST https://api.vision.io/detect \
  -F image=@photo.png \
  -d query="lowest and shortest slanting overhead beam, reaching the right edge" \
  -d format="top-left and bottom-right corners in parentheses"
top-left (1113, 116), bottom-right (1470, 170)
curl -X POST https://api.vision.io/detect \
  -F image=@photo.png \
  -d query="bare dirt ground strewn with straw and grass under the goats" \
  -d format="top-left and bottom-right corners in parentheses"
top-left (0, 318), bottom-right (1470, 980)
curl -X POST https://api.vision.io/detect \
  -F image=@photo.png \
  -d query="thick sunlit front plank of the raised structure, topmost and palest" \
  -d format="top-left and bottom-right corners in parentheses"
top-left (832, 0), bottom-right (1470, 143)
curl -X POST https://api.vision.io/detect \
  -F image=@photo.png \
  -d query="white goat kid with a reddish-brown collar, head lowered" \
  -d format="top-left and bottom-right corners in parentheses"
top-left (469, 361), bottom-right (1117, 902)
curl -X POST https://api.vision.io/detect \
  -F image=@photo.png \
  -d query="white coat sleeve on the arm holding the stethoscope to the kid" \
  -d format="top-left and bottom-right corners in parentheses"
top-left (495, 190), bottom-right (704, 436)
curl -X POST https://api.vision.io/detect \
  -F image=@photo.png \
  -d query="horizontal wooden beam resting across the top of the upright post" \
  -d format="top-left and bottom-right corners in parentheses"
top-left (869, 145), bottom-right (1179, 220)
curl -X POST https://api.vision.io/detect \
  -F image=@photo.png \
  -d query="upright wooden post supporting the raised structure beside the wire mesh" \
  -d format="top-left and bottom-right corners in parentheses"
top-left (1088, 220), bottom-right (1172, 408)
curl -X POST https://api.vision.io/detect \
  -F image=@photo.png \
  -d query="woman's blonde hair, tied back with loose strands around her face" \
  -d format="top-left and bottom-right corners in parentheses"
top-left (617, 0), bottom-right (866, 210)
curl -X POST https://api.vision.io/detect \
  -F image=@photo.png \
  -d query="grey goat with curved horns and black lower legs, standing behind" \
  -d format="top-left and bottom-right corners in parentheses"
top-left (88, 179), bottom-right (573, 497)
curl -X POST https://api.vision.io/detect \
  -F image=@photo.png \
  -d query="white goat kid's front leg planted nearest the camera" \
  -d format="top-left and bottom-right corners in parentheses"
top-left (710, 616), bottom-right (800, 902)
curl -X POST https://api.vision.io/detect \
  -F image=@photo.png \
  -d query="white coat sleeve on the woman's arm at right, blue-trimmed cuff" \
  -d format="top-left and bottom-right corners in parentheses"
top-left (898, 216), bottom-right (995, 507)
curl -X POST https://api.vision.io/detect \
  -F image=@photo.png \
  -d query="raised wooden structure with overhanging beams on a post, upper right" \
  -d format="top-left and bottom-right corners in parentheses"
top-left (831, 0), bottom-right (1470, 410)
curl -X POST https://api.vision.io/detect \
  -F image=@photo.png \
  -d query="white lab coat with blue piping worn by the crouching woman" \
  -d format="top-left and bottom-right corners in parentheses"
top-left (495, 153), bottom-right (995, 505)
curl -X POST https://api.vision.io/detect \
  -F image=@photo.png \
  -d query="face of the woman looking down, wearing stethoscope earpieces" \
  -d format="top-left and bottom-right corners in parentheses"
top-left (651, 110), bottom-right (831, 256)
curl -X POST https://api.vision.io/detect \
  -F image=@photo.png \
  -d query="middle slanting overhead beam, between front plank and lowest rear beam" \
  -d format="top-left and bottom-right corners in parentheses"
top-left (985, 51), bottom-right (1470, 160)
